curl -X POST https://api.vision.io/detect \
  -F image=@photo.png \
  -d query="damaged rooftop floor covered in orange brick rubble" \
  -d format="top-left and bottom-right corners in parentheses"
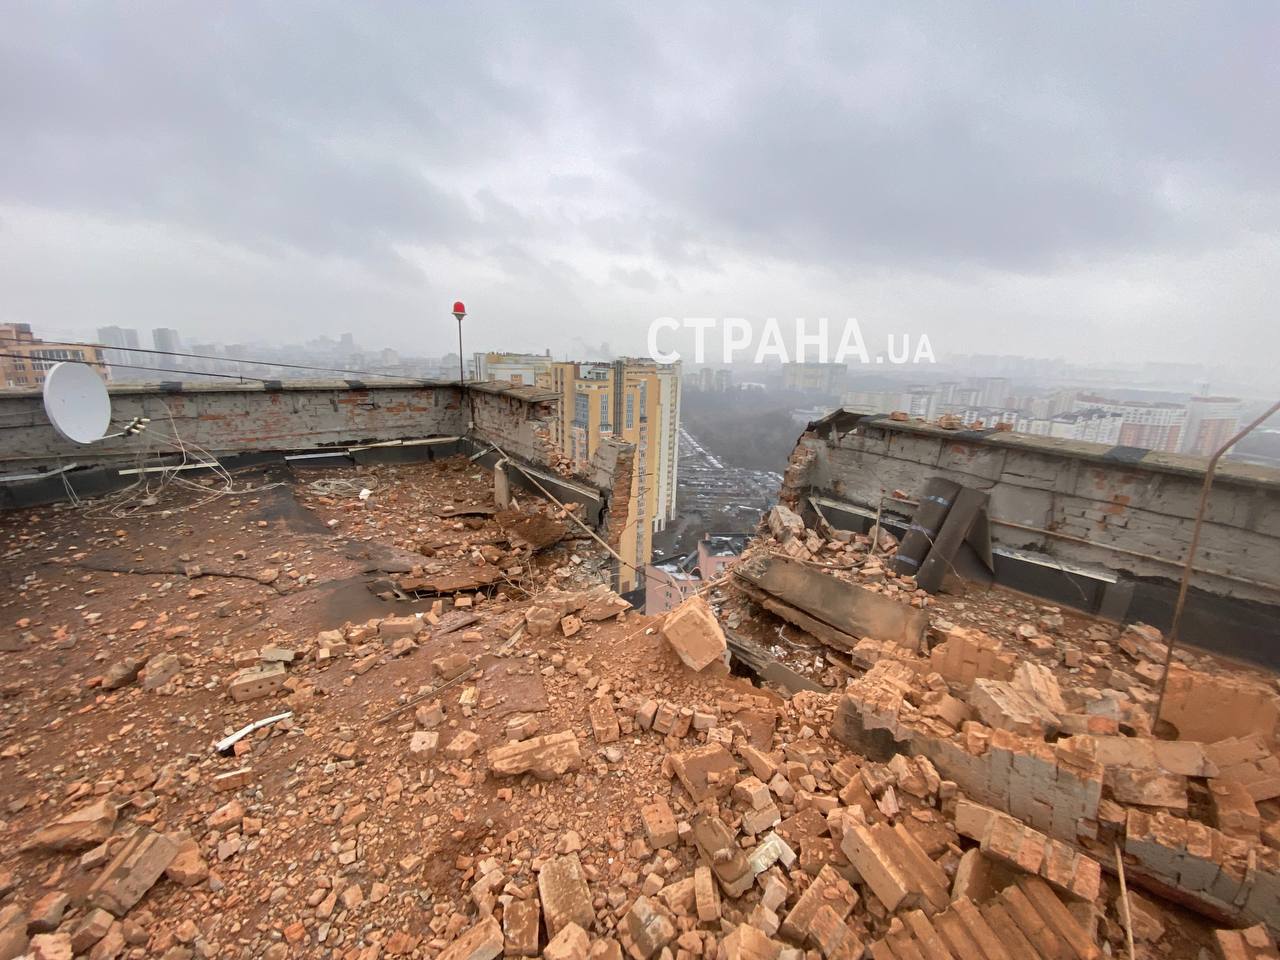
top-left (0, 442), bottom-right (1280, 960)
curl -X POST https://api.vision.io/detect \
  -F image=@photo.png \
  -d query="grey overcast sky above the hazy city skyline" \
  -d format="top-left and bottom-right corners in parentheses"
top-left (0, 0), bottom-right (1280, 365)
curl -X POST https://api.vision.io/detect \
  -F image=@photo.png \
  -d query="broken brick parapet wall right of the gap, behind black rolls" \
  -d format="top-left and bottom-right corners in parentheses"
top-left (781, 411), bottom-right (1280, 604)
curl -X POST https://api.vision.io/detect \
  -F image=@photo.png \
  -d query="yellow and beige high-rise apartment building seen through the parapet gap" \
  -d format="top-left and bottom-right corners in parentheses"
top-left (476, 353), bottom-right (681, 590)
